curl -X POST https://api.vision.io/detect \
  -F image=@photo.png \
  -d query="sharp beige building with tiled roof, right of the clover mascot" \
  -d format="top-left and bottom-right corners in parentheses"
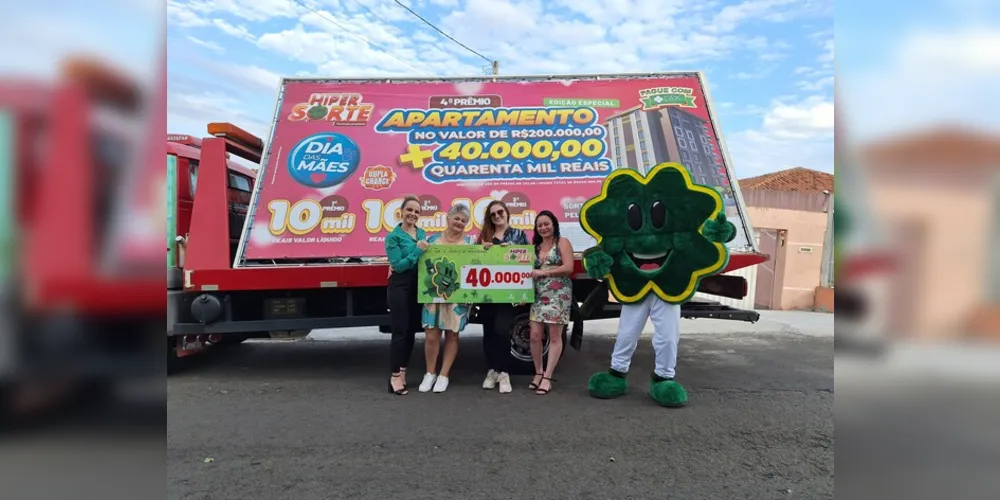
top-left (739, 167), bottom-right (834, 311)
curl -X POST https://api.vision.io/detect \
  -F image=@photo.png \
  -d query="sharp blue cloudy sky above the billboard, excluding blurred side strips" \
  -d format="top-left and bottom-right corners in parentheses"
top-left (167, 0), bottom-right (833, 177)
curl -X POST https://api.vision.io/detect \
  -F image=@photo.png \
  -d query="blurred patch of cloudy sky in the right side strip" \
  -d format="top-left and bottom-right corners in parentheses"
top-left (836, 0), bottom-right (1000, 143)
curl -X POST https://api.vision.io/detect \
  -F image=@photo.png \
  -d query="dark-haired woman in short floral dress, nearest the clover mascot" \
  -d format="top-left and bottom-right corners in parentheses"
top-left (528, 210), bottom-right (573, 395)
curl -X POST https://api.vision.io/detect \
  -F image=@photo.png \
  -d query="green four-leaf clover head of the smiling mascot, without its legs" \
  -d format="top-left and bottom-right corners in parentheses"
top-left (580, 163), bottom-right (736, 304)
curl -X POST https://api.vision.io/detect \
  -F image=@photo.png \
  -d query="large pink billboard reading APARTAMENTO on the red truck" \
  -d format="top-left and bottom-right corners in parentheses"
top-left (238, 73), bottom-right (746, 265)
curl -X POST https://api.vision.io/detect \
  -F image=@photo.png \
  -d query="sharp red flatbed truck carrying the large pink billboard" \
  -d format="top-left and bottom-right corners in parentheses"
top-left (167, 73), bottom-right (767, 371)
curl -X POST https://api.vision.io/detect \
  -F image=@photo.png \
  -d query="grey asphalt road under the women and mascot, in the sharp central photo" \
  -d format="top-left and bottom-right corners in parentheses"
top-left (167, 316), bottom-right (834, 500)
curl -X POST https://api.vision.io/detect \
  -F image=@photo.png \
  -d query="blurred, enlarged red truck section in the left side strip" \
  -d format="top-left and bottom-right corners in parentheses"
top-left (0, 57), bottom-right (166, 420)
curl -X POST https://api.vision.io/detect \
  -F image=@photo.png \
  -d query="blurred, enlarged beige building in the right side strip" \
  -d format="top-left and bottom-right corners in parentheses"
top-left (860, 130), bottom-right (1000, 338)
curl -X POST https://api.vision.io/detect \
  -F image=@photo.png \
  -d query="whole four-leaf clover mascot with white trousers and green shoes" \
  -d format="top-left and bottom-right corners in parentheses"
top-left (580, 163), bottom-right (736, 407)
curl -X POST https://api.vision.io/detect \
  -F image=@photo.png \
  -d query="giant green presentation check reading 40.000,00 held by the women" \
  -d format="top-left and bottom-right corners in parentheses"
top-left (417, 245), bottom-right (535, 304)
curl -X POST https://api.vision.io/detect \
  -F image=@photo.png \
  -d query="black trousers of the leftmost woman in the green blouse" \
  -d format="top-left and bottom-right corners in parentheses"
top-left (387, 269), bottom-right (421, 373)
